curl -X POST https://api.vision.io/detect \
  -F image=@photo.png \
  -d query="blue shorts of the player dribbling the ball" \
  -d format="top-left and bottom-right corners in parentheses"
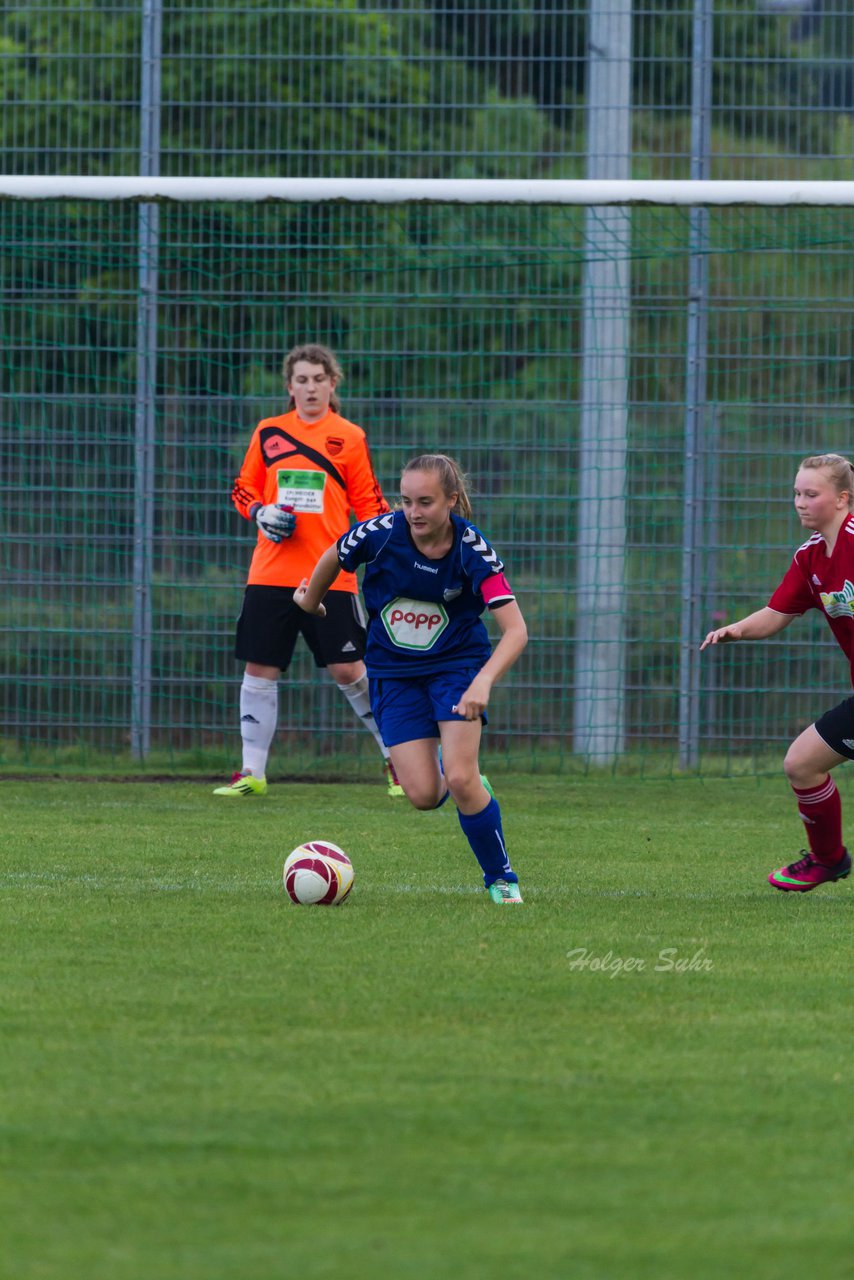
top-left (370, 667), bottom-right (487, 746)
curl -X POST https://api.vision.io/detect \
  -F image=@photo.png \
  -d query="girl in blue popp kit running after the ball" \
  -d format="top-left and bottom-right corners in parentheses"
top-left (293, 453), bottom-right (528, 904)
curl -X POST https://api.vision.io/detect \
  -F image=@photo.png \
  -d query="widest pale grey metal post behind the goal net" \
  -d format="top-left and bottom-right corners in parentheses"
top-left (572, 0), bottom-right (631, 764)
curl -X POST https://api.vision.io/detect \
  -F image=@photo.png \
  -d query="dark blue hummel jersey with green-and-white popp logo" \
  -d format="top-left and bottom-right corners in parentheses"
top-left (338, 511), bottom-right (513, 678)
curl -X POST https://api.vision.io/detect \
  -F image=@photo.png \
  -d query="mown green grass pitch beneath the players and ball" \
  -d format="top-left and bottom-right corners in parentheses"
top-left (0, 778), bottom-right (854, 1280)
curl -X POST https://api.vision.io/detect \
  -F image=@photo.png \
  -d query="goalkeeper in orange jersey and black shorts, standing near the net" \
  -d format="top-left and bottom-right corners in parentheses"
top-left (214, 343), bottom-right (403, 796)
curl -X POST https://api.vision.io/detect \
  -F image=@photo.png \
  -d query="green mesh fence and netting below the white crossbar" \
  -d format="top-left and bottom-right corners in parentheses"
top-left (0, 202), bottom-right (854, 776)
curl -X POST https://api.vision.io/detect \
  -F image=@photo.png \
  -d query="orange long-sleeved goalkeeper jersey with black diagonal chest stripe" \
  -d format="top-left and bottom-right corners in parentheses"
top-left (226, 410), bottom-right (388, 593)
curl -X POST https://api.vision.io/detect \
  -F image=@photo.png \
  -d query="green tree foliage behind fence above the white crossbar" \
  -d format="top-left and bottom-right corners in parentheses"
top-left (0, 0), bottom-right (854, 177)
